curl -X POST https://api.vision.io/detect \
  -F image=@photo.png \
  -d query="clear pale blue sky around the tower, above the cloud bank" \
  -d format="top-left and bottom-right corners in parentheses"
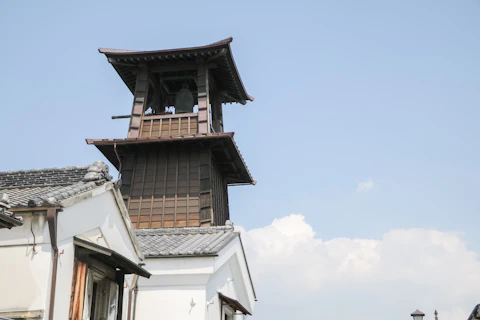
top-left (0, 0), bottom-right (480, 318)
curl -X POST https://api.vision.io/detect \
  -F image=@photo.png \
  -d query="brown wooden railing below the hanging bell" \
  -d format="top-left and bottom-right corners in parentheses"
top-left (140, 113), bottom-right (198, 138)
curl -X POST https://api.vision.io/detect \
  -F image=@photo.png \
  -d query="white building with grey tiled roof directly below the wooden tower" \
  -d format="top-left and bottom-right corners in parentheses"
top-left (136, 226), bottom-right (256, 320)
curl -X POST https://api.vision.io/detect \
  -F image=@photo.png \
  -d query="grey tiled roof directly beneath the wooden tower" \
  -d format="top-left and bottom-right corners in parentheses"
top-left (135, 226), bottom-right (239, 258)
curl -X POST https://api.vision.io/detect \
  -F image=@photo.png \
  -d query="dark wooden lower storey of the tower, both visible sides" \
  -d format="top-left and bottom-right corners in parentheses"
top-left (121, 143), bottom-right (229, 229)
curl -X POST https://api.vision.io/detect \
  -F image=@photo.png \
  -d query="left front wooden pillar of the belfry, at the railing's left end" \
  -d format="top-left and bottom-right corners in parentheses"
top-left (128, 65), bottom-right (149, 138)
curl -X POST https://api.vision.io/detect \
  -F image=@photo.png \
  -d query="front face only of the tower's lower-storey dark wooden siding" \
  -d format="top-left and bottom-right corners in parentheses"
top-left (122, 145), bottom-right (209, 228)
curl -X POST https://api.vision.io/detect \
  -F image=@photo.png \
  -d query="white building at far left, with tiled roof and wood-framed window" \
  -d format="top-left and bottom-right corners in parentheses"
top-left (0, 162), bottom-right (150, 319)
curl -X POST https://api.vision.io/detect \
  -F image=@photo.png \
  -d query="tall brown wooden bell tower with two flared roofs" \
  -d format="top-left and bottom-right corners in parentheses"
top-left (87, 38), bottom-right (255, 228)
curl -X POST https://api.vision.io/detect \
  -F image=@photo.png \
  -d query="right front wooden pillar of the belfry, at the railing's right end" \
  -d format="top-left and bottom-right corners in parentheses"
top-left (197, 59), bottom-right (210, 133)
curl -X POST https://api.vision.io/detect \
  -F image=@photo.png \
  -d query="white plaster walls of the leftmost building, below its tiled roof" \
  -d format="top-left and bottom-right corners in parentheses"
top-left (0, 186), bottom-right (139, 320)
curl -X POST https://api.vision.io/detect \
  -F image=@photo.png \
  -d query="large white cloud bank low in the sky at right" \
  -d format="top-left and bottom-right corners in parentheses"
top-left (239, 215), bottom-right (480, 320)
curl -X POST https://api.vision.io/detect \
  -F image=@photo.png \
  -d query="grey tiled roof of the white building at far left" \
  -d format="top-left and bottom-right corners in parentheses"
top-left (0, 161), bottom-right (112, 208)
